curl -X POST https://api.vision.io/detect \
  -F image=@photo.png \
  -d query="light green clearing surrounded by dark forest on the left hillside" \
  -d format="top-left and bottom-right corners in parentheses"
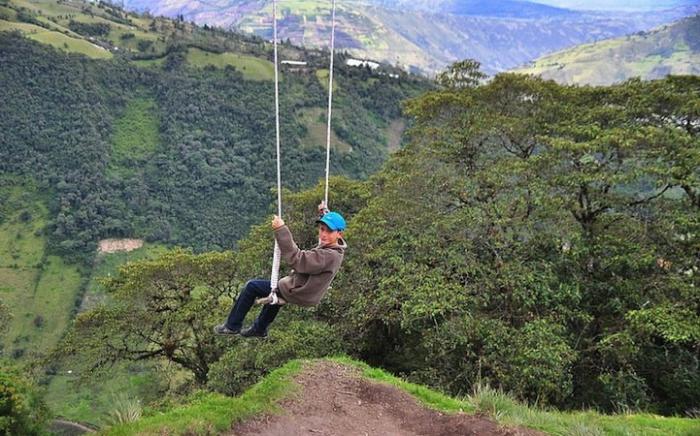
top-left (111, 98), bottom-right (160, 169)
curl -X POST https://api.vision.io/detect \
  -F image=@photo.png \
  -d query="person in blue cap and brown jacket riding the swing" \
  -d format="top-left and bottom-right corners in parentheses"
top-left (214, 202), bottom-right (347, 338)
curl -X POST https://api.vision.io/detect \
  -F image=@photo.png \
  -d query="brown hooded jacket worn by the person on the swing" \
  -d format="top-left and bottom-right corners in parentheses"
top-left (275, 226), bottom-right (347, 306)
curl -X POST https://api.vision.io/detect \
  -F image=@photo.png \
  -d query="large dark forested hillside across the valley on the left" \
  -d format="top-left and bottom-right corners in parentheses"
top-left (0, 0), bottom-right (430, 425)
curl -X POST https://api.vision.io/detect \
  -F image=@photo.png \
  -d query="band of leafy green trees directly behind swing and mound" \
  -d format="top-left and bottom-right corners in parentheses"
top-left (56, 74), bottom-right (700, 430)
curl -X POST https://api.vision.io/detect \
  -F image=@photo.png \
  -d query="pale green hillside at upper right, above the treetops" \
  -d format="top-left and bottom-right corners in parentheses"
top-left (514, 15), bottom-right (700, 85)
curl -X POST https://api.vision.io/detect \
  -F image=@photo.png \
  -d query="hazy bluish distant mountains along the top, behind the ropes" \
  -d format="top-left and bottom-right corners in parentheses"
top-left (124, 0), bottom-right (697, 74)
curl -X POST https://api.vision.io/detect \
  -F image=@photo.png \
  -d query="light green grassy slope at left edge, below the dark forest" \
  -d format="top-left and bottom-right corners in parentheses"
top-left (0, 177), bottom-right (82, 356)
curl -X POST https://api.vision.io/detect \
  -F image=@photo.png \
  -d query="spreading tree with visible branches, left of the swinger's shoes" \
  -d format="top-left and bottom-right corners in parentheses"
top-left (57, 250), bottom-right (240, 384)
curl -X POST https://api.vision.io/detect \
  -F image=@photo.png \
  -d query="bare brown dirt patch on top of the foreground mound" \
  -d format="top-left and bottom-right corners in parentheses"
top-left (229, 362), bottom-right (542, 436)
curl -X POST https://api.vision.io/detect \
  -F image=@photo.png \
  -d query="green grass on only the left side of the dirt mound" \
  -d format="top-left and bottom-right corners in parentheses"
top-left (106, 360), bottom-right (302, 435)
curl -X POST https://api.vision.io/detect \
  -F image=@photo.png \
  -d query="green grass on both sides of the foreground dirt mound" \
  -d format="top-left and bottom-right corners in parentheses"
top-left (101, 356), bottom-right (700, 436)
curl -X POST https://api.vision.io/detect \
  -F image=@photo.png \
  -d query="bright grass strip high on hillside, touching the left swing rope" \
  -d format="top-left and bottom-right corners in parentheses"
top-left (187, 48), bottom-right (275, 80)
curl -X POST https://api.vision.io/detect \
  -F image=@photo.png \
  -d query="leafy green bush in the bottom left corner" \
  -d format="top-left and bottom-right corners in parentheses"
top-left (0, 362), bottom-right (49, 435)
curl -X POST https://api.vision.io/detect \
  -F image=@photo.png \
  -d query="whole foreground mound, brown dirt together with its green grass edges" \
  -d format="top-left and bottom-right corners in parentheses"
top-left (107, 358), bottom-right (700, 436)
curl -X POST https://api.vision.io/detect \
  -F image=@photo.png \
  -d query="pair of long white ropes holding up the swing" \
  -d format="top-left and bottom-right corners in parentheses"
top-left (270, 0), bottom-right (335, 294)
